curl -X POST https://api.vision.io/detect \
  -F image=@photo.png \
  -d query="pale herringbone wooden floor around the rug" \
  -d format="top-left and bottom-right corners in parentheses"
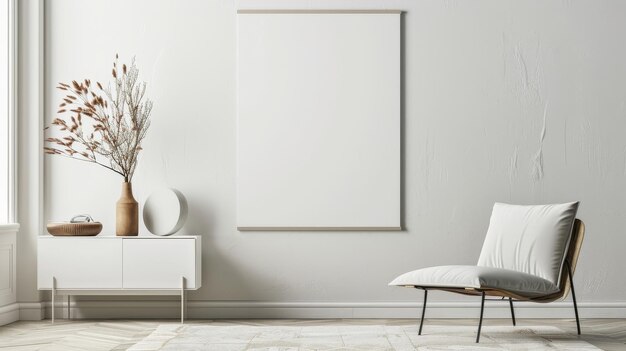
top-left (0, 319), bottom-right (626, 351)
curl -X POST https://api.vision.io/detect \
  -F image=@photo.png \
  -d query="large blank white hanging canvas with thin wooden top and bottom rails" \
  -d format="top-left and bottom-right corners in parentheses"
top-left (237, 11), bottom-right (400, 230)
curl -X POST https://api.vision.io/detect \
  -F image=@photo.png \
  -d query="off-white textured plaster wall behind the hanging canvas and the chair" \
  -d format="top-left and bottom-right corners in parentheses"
top-left (21, 0), bottom-right (626, 317)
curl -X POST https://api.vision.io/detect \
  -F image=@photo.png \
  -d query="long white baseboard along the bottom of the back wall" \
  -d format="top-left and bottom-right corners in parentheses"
top-left (30, 300), bottom-right (626, 320)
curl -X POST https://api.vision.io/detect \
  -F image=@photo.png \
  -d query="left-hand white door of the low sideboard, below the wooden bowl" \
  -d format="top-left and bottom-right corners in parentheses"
top-left (37, 237), bottom-right (122, 289)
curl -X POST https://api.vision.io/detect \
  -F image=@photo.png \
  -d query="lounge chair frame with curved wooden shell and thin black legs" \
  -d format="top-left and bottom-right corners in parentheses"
top-left (414, 218), bottom-right (585, 343)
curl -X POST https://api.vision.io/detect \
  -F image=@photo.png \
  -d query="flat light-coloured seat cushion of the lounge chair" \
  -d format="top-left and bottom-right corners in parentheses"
top-left (389, 266), bottom-right (559, 297)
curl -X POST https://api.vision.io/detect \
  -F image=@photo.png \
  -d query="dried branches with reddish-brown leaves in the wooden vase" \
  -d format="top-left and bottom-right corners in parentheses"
top-left (44, 55), bottom-right (152, 182)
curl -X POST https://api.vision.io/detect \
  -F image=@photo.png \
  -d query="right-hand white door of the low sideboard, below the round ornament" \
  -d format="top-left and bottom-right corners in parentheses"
top-left (123, 238), bottom-right (196, 289)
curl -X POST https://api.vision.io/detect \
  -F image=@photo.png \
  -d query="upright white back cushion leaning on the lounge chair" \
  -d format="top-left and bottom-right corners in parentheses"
top-left (478, 202), bottom-right (578, 285)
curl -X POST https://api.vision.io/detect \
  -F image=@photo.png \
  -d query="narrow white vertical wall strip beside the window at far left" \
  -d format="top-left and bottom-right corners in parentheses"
top-left (16, 0), bottom-right (44, 319)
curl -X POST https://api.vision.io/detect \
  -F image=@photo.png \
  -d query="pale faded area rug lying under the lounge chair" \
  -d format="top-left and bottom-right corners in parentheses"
top-left (128, 324), bottom-right (600, 351)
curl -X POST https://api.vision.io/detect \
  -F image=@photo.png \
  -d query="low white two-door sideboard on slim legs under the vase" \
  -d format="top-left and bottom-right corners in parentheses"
top-left (37, 235), bottom-right (202, 322)
